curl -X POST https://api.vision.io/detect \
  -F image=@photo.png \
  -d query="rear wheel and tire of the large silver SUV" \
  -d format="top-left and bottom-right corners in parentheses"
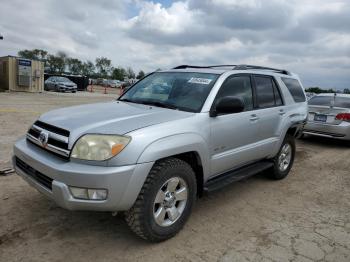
top-left (269, 134), bottom-right (295, 180)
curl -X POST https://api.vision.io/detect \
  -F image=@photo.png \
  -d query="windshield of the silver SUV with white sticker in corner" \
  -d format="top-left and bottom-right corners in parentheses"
top-left (119, 72), bottom-right (219, 112)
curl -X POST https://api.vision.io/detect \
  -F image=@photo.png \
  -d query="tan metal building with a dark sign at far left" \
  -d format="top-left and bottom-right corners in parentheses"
top-left (0, 56), bottom-right (44, 92)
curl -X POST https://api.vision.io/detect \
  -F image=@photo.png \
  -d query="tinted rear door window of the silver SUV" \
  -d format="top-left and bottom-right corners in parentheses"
top-left (254, 76), bottom-right (275, 108)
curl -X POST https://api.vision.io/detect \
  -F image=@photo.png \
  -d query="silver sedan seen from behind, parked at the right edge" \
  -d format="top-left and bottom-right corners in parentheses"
top-left (303, 93), bottom-right (350, 140)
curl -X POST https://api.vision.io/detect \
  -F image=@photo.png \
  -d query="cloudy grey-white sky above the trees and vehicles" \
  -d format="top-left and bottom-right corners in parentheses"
top-left (0, 0), bottom-right (350, 89)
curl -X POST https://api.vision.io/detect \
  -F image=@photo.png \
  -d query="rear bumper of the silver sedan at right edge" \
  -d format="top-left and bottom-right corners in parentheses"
top-left (303, 121), bottom-right (350, 140)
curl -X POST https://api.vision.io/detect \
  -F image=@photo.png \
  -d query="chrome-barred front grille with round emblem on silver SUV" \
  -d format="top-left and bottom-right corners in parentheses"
top-left (27, 121), bottom-right (70, 160)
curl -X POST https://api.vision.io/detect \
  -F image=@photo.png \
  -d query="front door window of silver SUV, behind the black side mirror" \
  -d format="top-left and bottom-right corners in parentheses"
top-left (216, 75), bottom-right (253, 111)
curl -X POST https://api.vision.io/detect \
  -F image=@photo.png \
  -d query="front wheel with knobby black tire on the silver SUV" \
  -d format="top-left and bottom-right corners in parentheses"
top-left (125, 158), bottom-right (197, 242)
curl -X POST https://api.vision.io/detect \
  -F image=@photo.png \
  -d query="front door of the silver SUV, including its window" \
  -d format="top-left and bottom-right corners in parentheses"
top-left (210, 74), bottom-right (259, 175)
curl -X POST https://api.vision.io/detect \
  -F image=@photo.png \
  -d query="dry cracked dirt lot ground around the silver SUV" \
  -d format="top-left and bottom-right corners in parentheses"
top-left (0, 93), bottom-right (350, 262)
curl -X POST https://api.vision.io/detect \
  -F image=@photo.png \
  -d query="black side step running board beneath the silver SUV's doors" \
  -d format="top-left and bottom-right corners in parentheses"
top-left (204, 160), bottom-right (273, 192)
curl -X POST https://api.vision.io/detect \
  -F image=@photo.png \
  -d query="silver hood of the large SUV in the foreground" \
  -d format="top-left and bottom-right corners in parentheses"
top-left (39, 101), bottom-right (194, 143)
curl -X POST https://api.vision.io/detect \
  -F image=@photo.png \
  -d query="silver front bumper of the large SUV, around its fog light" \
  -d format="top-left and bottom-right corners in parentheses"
top-left (13, 138), bottom-right (153, 211)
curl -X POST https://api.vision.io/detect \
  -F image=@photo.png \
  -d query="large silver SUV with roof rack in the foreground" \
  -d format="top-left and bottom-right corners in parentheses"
top-left (13, 65), bottom-right (307, 242)
